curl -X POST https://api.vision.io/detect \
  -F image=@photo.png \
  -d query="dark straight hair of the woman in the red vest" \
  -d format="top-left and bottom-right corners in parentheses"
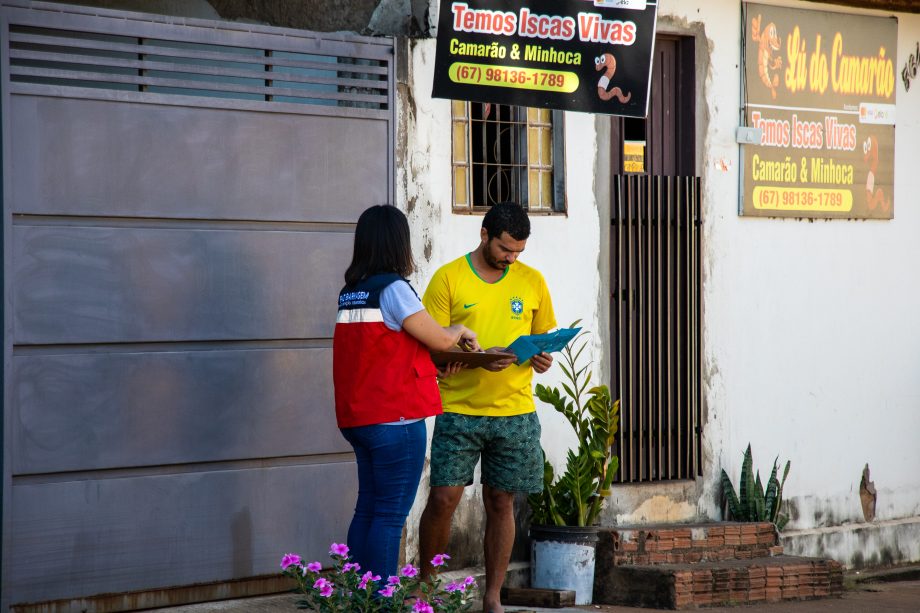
top-left (345, 204), bottom-right (415, 285)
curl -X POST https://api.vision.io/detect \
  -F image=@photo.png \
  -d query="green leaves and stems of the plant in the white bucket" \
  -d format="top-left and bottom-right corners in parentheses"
top-left (527, 321), bottom-right (620, 526)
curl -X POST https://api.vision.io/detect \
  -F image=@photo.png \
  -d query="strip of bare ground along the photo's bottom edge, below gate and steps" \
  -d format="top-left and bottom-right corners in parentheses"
top-left (149, 575), bottom-right (920, 613)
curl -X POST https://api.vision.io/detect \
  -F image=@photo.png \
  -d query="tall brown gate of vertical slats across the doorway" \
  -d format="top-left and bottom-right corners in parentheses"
top-left (610, 175), bottom-right (702, 482)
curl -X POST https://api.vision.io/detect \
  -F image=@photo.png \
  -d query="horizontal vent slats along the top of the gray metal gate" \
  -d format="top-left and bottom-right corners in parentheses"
top-left (9, 25), bottom-right (391, 110)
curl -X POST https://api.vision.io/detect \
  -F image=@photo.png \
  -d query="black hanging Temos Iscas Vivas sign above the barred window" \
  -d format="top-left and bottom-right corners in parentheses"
top-left (432, 0), bottom-right (658, 117)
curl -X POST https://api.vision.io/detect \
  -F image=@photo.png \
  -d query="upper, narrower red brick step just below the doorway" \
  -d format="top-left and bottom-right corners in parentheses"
top-left (597, 522), bottom-right (783, 566)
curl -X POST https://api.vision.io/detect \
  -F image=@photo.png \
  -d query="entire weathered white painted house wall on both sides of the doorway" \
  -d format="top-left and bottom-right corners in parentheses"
top-left (397, 0), bottom-right (920, 562)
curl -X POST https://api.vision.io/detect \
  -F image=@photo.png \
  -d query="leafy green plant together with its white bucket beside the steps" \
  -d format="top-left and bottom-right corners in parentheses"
top-left (527, 322), bottom-right (620, 604)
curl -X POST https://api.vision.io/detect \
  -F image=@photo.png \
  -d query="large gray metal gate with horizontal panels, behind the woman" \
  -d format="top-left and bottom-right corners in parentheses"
top-left (0, 1), bottom-right (395, 611)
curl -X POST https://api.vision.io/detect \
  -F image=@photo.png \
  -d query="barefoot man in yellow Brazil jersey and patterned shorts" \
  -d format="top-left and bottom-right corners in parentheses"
top-left (419, 203), bottom-right (556, 613)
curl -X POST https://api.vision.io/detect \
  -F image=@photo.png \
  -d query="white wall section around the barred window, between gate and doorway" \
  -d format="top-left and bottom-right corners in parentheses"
top-left (397, 39), bottom-right (603, 558)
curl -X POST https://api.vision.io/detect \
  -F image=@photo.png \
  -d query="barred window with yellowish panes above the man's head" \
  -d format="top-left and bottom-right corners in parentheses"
top-left (451, 100), bottom-right (565, 213)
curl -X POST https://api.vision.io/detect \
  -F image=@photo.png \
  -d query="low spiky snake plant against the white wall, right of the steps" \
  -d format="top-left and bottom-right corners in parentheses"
top-left (722, 444), bottom-right (791, 530)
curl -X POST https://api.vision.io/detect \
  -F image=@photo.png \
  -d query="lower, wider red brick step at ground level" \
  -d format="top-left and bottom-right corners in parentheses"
top-left (594, 556), bottom-right (843, 609)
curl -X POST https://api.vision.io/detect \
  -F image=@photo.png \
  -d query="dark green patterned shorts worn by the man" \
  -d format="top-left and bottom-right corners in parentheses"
top-left (431, 412), bottom-right (543, 493)
